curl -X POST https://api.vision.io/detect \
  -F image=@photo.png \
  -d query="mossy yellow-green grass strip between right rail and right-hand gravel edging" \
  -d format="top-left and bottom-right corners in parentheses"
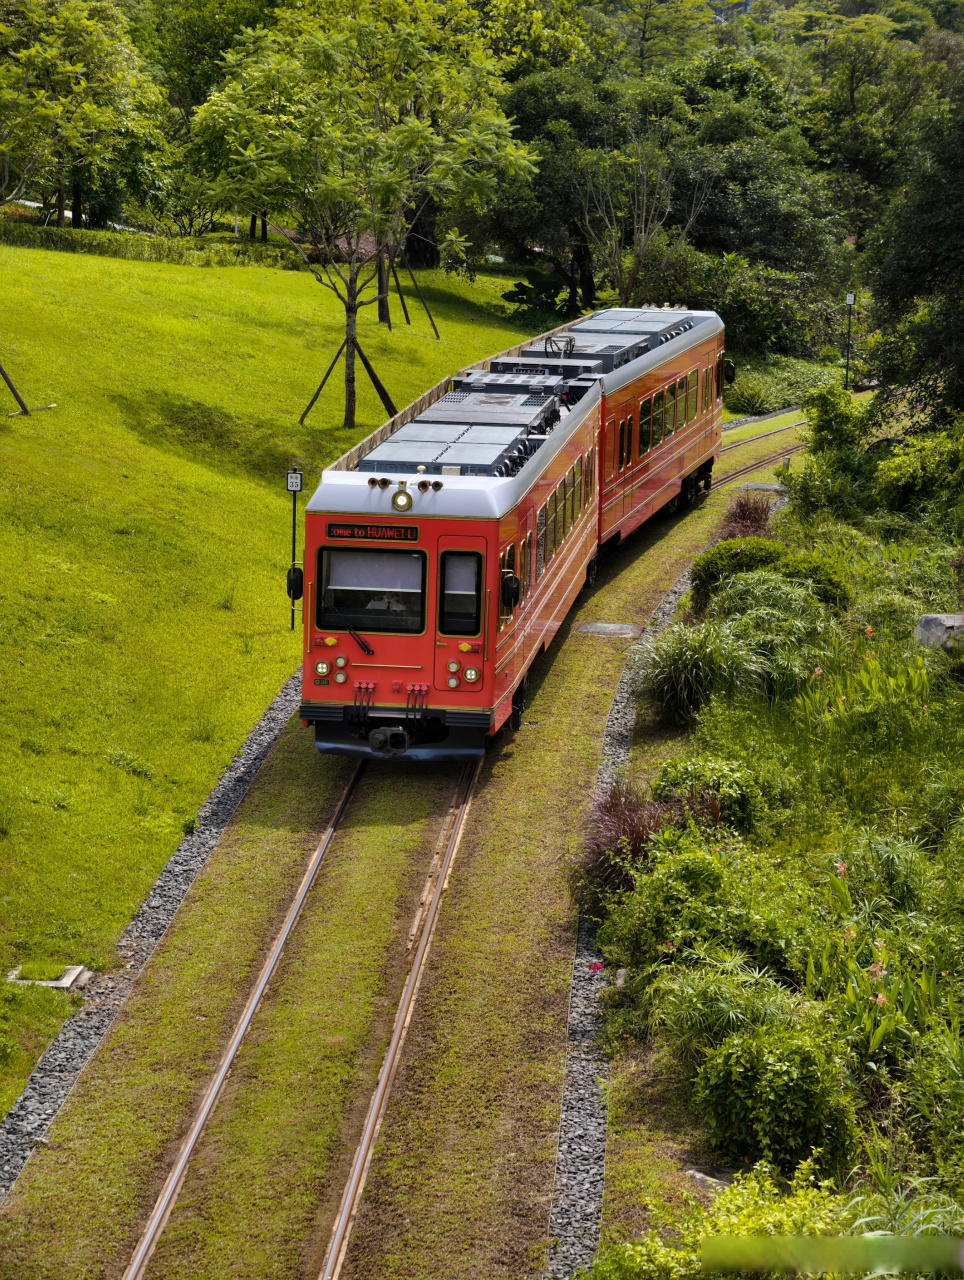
top-left (343, 494), bottom-right (727, 1280)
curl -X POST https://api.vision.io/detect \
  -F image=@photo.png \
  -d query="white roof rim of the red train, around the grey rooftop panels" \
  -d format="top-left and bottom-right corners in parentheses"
top-left (307, 307), bottom-right (723, 522)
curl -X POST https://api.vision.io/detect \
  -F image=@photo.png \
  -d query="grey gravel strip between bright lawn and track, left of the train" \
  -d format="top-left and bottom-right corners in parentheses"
top-left (0, 671), bottom-right (301, 1203)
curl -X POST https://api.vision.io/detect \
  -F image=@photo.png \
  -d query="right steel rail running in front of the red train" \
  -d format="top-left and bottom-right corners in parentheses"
top-left (319, 760), bottom-right (483, 1280)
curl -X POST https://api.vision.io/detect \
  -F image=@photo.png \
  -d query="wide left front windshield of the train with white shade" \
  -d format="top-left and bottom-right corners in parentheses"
top-left (315, 547), bottom-right (425, 635)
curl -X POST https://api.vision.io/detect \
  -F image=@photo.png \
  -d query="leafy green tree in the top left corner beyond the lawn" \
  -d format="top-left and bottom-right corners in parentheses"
top-left (0, 0), bottom-right (157, 207)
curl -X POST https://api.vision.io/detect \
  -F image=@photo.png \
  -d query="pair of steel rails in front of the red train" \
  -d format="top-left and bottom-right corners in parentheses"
top-left (123, 760), bottom-right (481, 1280)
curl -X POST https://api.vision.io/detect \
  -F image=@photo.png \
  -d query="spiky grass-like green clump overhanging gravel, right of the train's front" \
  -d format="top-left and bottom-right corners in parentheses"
top-left (640, 622), bottom-right (762, 721)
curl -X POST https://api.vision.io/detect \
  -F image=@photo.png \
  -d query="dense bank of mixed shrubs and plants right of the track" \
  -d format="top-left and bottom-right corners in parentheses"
top-left (577, 378), bottom-right (964, 1277)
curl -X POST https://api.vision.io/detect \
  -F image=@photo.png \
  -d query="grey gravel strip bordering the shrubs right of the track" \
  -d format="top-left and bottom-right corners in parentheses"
top-left (545, 570), bottom-right (690, 1280)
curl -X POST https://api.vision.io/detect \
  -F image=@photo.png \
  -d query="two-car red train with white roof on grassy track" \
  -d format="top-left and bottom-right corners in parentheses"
top-left (293, 307), bottom-right (725, 759)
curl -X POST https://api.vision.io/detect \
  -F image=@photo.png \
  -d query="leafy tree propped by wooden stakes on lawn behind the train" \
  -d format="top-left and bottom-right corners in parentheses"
top-left (196, 0), bottom-right (530, 428)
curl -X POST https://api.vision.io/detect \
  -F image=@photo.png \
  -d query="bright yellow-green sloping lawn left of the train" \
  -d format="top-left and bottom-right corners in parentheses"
top-left (0, 246), bottom-right (530, 1114)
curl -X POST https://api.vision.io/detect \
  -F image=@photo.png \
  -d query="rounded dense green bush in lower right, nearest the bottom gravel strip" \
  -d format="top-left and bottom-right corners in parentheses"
top-left (695, 1028), bottom-right (854, 1170)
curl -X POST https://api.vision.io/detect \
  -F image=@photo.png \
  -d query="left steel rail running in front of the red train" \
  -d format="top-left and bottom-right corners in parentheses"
top-left (123, 760), bottom-right (365, 1280)
